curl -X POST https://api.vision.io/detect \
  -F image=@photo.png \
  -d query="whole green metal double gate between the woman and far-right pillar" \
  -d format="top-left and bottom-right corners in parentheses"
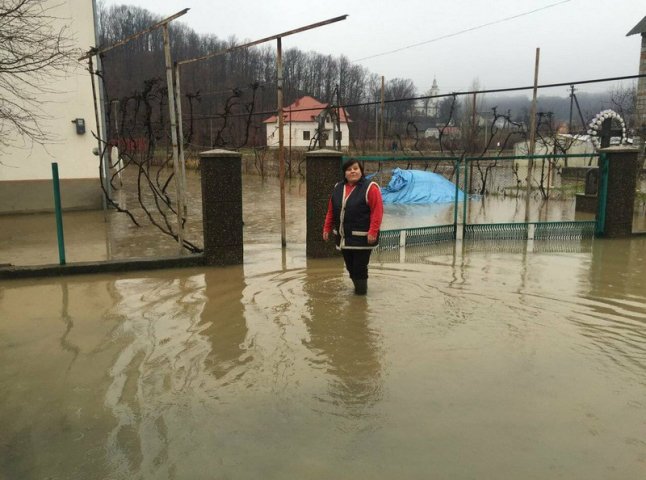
top-left (343, 153), bottom-right (607, 250)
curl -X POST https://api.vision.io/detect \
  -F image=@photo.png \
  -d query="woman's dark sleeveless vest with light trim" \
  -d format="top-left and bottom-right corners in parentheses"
top-left (332, 177), bottom-right (377, 250)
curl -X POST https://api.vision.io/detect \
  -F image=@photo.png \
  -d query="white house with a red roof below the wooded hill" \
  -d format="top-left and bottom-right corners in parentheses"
top-left (263, 96), bottom-right (350, 148)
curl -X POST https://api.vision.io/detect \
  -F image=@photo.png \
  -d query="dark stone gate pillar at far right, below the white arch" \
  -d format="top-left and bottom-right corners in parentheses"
top-left (600, 146), bottom-right (638, 238)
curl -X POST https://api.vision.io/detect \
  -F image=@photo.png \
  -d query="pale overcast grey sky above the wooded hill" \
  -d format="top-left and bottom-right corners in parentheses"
top-left (100, 0), bottom-right (646, 94)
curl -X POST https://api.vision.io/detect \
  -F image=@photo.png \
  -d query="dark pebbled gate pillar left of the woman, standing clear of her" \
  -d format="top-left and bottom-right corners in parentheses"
top-left (200, 150), bottom-right (243, 265)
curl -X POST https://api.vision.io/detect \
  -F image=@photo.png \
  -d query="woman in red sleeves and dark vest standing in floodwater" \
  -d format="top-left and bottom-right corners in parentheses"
top-left (323, 158), bottom-right (384, 295)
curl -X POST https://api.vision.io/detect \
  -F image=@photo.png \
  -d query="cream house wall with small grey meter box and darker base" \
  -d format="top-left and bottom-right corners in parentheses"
top-left (0, 0), bottom-right (101, 213)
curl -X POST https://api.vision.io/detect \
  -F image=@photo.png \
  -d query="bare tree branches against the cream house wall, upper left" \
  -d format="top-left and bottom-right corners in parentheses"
top-left (0, 0), bottom-right (78, 148)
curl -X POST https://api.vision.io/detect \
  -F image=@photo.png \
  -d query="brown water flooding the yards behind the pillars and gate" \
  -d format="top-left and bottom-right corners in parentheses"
top-left (0, 171), bottom-right (646, 266)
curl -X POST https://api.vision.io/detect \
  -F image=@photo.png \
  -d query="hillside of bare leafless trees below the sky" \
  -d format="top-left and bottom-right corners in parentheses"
top-left (99, 5), bottom-right (630, 148)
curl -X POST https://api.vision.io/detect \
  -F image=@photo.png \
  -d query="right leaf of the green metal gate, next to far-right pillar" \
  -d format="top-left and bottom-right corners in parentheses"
top-left (462, 153), bottom-right (606, 240)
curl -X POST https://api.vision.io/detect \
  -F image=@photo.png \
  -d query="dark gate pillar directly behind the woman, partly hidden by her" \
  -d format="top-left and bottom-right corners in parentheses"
top-left (305, 150), bottom-right (342, 258)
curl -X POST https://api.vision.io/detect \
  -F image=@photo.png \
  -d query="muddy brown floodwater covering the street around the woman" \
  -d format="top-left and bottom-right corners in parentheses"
top-left (0, 171), bottom-right (646, 480)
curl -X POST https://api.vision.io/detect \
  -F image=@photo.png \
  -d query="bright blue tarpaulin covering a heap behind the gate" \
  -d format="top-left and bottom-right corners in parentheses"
top-left (381, 168), bottom-right (464, 204)
